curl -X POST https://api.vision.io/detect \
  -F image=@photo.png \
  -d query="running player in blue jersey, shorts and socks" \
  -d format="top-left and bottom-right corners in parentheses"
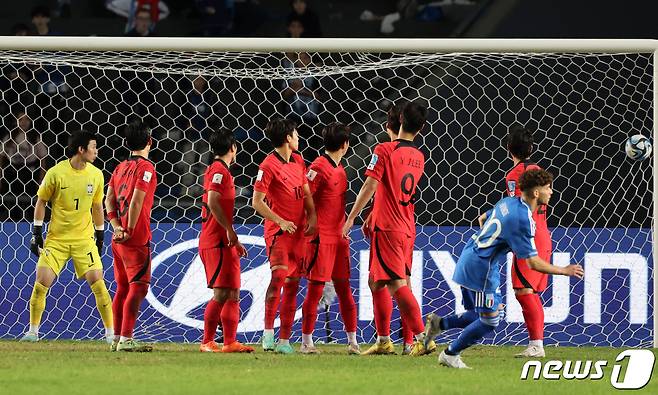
top-left (425, 170), bottom-right (583, 369)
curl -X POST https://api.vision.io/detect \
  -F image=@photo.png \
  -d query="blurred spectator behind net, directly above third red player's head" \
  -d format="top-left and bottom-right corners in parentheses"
top-left (281, 52), bottom-right (320, 125)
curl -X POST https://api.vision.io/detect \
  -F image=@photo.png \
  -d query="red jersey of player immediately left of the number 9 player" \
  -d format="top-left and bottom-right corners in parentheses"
top-left (306, 154), bottom-right (347, 243)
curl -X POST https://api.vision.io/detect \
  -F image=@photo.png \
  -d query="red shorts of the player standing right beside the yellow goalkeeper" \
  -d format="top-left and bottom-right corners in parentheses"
top-left (112, 242), bottom-right (151, 283)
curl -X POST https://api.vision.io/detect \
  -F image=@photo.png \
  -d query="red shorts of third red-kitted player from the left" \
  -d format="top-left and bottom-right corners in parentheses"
top-left (265, 232), bottom-right (306, 277)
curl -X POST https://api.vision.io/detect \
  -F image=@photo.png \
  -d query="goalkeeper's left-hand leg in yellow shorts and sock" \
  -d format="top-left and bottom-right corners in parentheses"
top-left (21, 239), bottom-right (70, 342)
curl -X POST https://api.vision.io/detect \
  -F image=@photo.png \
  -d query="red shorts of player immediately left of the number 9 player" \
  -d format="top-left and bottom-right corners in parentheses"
top-left (301, 236), bottom-right (350, 282)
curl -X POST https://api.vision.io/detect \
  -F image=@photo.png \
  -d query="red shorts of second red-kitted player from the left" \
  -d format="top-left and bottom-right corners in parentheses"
top-left (199, 247), bottom-right (240, 289)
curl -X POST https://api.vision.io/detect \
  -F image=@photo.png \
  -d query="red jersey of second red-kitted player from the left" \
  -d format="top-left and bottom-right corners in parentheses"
top-left (199, 159), bottom-right (235, 248)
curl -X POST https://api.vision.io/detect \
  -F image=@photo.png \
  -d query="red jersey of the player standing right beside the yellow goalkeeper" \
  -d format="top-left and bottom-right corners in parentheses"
top-left (109, 156), bottom-right (158, 246)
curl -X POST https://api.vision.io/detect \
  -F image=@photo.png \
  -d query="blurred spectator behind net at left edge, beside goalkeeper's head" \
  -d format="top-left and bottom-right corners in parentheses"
top-left (0, 111), bottom-right (48, 198)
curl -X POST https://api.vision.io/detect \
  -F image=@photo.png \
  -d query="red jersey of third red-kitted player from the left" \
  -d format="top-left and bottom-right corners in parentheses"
top-left (254, 151), bottom-right (307, 237)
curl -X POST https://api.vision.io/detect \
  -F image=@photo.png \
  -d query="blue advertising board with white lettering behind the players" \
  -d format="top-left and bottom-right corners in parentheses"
top-left (0, 222), bottom-right (654, 347)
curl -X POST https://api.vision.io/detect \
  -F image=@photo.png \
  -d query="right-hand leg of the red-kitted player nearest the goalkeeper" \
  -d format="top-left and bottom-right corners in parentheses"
top-left (117, 246), bottom-right (152, 352)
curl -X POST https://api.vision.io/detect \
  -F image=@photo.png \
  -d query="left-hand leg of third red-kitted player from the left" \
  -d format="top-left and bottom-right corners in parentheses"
top-left (262, 236), bottom-right (288, 351)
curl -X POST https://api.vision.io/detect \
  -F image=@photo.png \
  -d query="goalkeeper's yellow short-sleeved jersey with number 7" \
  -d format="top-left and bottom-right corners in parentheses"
top-left (37, 159), bottom-right (105, 242)
